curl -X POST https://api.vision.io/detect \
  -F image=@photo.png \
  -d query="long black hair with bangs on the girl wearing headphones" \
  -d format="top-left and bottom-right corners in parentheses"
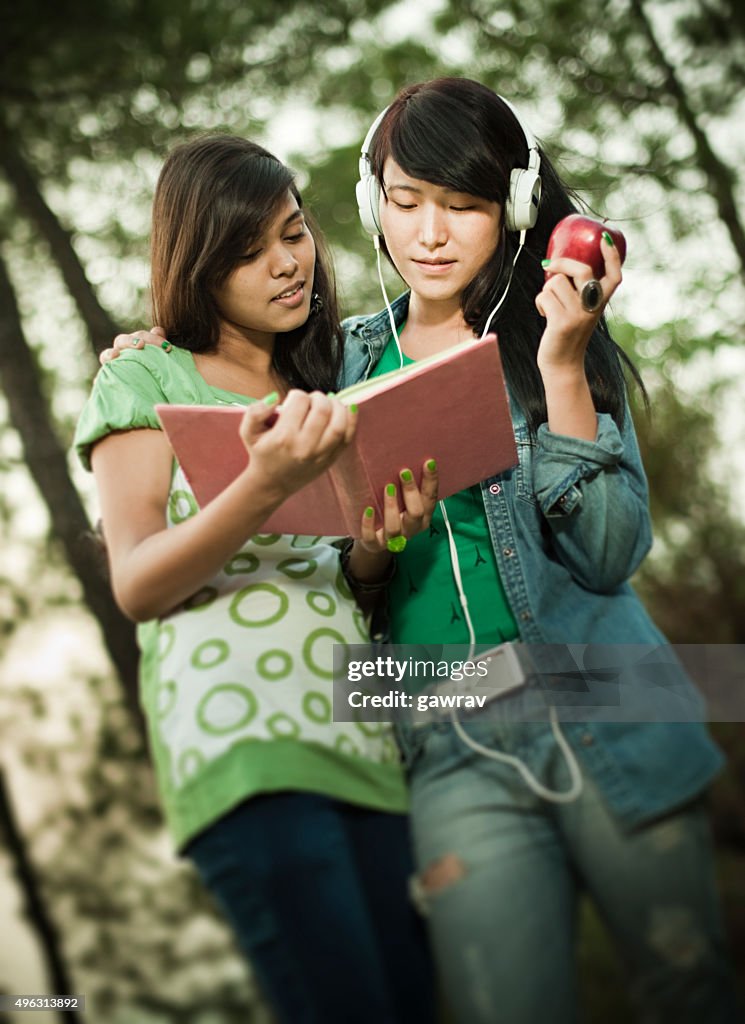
top-left (370, 78), bottom-right (644, 431)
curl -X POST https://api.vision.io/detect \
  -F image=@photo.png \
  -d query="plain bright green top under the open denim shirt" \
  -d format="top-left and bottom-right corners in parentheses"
top-left (370, 335), bottom-right (518, 646)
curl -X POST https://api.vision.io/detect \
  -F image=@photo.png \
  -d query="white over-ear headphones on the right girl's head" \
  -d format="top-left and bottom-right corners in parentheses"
top-left (356, 96), bottom-right (540, 237)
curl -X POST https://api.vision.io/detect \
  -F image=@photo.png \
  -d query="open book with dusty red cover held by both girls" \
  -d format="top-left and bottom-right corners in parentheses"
top-left (156, 335), bottom-right (518, 537)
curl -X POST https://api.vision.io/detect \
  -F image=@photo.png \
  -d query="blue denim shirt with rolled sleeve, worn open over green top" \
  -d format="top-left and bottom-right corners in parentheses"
top-left (341, 294), bottom-right (722, 827)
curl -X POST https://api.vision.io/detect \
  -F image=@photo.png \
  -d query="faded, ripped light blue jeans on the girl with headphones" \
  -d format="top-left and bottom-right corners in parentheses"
top-left (399, 714), bottom-right (740, 1024)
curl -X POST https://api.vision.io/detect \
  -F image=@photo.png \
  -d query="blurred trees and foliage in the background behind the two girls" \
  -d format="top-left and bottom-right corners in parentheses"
top-left (0, 0), bottom-right (745, 1024)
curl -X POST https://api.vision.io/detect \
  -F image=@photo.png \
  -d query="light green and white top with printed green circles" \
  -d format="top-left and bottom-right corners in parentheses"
top-left (75, 346), bottom-right (407, 848)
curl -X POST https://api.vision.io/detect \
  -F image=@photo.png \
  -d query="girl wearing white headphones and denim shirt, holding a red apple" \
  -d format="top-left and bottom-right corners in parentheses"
top-left (345, 79), bottom-right (738, 1024)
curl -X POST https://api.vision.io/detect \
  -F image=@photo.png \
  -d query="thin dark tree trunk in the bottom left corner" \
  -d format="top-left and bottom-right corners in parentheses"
top-left (0, 770), bottom-right (83, 1024)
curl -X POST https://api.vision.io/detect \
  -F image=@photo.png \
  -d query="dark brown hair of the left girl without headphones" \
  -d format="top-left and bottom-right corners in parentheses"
top-left (150, 135), bottom-right (343, 391)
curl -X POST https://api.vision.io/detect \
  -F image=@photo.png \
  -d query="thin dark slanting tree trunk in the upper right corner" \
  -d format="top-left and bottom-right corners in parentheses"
top-left (631, 0), bottom-right (745, 282)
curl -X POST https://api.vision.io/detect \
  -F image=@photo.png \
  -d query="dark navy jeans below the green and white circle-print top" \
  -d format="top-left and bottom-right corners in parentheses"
top-left (185, 793), bottom-right (435, 1024)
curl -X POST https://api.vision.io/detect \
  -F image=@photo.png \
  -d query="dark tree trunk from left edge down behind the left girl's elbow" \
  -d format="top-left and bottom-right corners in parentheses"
top-left (0, 251), bottom-right (144, 736)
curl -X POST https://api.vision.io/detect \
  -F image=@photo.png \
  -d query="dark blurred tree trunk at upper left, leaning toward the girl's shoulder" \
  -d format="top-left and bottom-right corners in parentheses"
top-left (0, 124), bottom-right (119, 354)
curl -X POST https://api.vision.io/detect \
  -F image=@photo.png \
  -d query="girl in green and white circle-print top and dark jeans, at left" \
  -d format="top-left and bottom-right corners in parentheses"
top-left (76, 136), bottom-right (434, 1024)
